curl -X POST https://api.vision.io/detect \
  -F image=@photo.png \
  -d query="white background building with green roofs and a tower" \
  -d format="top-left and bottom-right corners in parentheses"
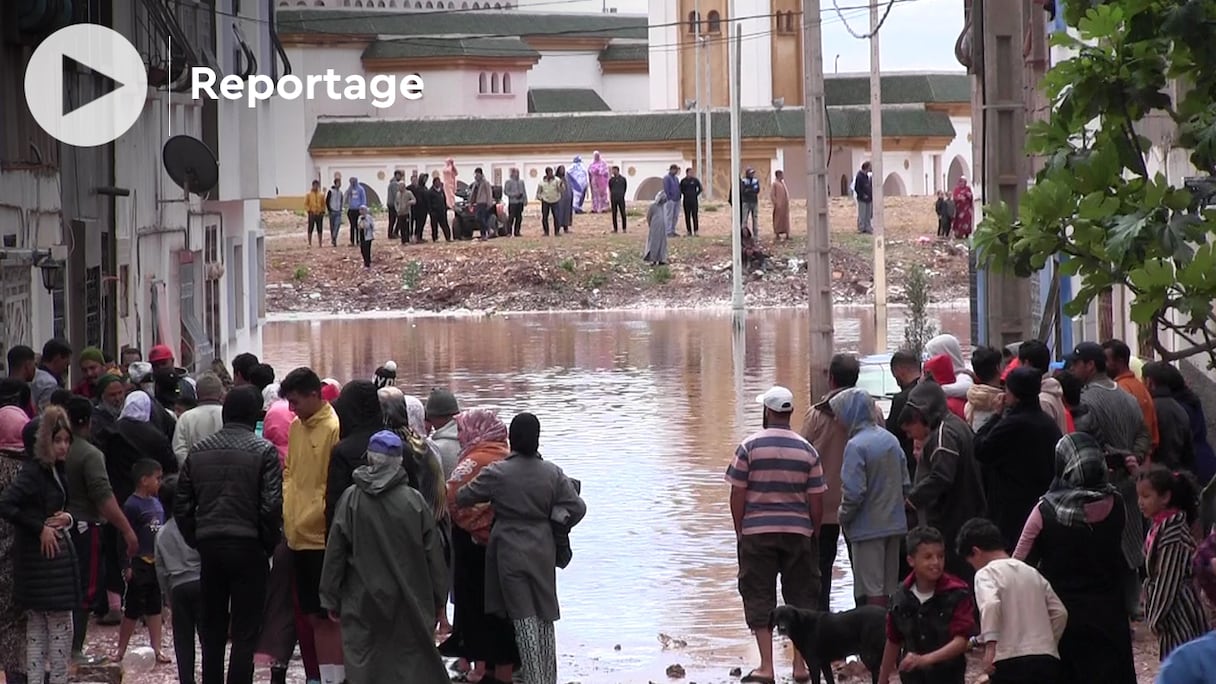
top-left (265, 0), bottom-right (970, 208)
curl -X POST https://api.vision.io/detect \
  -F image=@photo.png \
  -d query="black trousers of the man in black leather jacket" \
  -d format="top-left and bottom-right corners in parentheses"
top-left (198, 539), bottom-right (270, 684)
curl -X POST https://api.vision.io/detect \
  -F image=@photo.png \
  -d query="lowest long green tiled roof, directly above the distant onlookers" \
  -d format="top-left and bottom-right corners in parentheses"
top-left (309, 107), bottom-right (955, 150)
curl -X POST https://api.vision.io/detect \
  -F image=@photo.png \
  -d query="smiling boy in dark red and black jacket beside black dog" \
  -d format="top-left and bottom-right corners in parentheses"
top-left (878, 527), bottom-right (975, 684)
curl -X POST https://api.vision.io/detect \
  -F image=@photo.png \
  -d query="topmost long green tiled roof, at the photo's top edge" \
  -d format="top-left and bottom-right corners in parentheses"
top-left (275, 10), bottom-right (648, 40)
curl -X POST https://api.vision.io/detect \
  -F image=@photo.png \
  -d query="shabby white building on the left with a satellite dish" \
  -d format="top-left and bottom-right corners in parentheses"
top-left (0, 2), bottom-right (274, 369)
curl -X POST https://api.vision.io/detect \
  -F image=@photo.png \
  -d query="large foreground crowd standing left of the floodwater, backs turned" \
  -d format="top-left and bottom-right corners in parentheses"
top-left (0, 340), bottom-right (586, 684)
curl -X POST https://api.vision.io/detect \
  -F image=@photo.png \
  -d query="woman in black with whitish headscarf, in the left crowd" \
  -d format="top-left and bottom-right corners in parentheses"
top-left (98, 389), bottom-right (178, 501)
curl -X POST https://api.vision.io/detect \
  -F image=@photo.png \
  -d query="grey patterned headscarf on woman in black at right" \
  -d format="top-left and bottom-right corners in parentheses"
top-left (1043, 432), bottom-right (1119, 527)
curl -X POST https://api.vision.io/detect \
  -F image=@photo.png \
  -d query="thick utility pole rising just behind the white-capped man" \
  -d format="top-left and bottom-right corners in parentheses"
top-left (803, 0), bottom-right (835, 402)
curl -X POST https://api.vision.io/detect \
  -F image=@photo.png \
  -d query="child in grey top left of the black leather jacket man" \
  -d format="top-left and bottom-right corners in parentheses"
top-left (156, 475), bottom-right (203, 684)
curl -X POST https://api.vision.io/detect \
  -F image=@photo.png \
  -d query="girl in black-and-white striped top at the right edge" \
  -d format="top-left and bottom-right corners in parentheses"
top-left (1136, 465), bottom-right (1207, 660)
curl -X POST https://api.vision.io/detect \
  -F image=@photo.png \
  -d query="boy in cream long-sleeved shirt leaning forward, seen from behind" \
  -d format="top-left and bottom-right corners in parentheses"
top-left (958, 517), bottom-right (1068, 684)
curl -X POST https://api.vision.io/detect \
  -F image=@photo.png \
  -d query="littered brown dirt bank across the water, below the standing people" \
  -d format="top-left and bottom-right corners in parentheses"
top-left (263, 197), bottom-right (968, 314)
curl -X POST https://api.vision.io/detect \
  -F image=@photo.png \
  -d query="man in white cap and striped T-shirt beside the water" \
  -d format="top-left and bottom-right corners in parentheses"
top-left (726, 386), bottom-right (827, 684)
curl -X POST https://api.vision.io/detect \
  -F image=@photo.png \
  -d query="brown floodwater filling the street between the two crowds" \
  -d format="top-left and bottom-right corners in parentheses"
top-left (263, 308), bottom-right (968, 683)
